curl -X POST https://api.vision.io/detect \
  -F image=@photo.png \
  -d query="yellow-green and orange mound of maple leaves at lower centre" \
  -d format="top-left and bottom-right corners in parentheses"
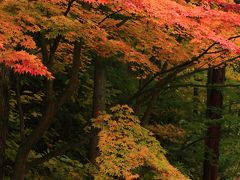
top-left (94, 105), bottom-right (187, 179)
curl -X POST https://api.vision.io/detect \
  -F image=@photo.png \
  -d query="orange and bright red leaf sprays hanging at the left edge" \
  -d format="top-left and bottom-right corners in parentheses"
top-left (0, 8), bottom-right (53, 78)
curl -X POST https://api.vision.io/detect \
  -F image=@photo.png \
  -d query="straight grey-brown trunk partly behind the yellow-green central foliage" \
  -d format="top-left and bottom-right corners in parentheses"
top-left (89, 58), bottom-right (106, 163)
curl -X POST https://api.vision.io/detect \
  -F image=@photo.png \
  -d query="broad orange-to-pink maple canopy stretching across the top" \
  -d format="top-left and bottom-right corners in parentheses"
top-left (0, 0), bottom-right (240, 79)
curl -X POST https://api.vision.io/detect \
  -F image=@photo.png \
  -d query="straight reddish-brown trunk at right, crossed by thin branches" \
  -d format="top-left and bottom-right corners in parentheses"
top-left (203, 67), bottom-right (225, 180)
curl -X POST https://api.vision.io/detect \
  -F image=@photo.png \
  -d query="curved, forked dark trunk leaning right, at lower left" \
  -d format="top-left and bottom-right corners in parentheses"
top-left (12, 43), bottom-right (81, 180)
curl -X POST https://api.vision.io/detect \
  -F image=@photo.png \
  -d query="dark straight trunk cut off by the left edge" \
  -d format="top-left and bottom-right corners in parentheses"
top-left (0, 66), bottom-right (9, 179)
